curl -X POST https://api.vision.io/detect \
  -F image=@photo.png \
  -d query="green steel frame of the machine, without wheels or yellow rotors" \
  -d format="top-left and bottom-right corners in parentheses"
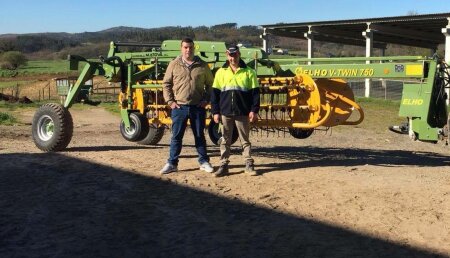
top-left (64, 43), bottom-right (448, 141)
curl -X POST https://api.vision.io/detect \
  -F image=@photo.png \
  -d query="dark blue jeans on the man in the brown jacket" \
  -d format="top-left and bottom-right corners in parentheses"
top-left (167, 105), bottom-right (209, 165)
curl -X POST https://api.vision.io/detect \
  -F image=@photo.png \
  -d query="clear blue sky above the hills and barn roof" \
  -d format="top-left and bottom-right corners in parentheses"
top-left (0, 0), bottom-right (450, 34)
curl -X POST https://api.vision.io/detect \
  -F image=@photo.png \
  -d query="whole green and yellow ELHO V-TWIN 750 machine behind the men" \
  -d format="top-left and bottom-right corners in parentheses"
top-left (32, 40), bottom-right (449, 151)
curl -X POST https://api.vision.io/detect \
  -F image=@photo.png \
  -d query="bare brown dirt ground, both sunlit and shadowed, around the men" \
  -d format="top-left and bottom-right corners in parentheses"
top-left (0, 107), bottom-right (450, 257)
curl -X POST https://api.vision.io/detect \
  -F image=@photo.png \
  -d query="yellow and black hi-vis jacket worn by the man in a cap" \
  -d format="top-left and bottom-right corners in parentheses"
top-left (211, 60), bottom-right (259, 116)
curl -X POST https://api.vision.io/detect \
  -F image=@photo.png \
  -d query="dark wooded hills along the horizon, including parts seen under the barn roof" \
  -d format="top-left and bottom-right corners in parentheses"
top-left (0, 23), bottom-right (442, 63)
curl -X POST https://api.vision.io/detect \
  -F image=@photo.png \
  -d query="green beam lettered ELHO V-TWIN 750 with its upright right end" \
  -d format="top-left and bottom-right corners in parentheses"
top-left (271, 56), bottom-right (449, 142)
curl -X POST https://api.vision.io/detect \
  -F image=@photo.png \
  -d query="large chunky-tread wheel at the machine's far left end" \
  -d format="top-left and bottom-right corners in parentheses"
top-left (31, 103), bottom-right (73, 151)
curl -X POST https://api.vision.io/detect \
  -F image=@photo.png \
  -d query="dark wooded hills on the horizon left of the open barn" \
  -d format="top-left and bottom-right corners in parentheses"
top-left (0, 23), bottom-right (262, 60)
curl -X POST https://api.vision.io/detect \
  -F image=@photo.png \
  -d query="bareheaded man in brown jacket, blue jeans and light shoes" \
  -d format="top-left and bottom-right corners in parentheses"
top-left (160, 38), bottom-right (214, 174)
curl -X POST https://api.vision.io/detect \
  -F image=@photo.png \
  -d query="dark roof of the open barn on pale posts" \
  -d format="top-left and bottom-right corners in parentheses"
top-left (261, 13), bottom-right (450, 49)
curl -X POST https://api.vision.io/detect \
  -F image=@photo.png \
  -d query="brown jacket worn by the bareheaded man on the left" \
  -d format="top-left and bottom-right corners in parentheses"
top-left (163, 56), bottom-right (214, 105)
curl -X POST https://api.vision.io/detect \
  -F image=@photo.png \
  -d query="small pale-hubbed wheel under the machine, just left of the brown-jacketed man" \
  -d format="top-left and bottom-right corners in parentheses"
top-left (120, 112), bottom-right (149, 142)
